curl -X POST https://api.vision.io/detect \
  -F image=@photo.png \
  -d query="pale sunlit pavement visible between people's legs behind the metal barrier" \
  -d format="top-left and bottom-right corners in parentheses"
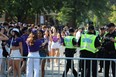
top-left (0, 49), bottom-right (112, 77)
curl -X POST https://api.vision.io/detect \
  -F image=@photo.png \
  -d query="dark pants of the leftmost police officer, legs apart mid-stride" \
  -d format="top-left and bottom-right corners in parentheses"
top-left (62, 49), bottom-right (77, 77)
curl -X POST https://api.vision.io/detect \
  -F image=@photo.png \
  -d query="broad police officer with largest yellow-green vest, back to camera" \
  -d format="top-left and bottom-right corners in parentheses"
top-left (78, 25), bottom-right (100, 77)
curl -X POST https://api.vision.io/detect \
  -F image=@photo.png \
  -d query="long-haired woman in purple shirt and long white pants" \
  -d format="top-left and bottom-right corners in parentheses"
top-left (26, 30), bottom-right (42, 77)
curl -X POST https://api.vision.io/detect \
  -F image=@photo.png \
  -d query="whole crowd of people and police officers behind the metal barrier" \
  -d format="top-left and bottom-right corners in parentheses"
top-left (0, 22), bottom-right (116, 77)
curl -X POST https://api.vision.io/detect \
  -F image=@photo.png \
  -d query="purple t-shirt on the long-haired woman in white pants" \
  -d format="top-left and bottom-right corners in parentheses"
top-left (28, 39), bottom-right (42, 52)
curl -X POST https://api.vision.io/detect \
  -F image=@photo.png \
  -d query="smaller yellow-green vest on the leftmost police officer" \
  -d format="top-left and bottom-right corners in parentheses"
top-left (64, 36), bottom-right (76, 49)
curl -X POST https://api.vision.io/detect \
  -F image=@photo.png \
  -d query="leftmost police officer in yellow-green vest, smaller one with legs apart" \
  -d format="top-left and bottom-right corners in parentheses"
top-left (62, 28), bottom-right (77, 77)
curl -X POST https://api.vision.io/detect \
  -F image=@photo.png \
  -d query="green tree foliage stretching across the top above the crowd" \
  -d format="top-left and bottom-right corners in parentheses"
top-left (0, 0), bottom-right (116, 26)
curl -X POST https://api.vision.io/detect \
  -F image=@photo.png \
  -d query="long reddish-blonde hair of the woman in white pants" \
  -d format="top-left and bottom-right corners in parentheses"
top-left (27, 31), bottom-right (38, 46)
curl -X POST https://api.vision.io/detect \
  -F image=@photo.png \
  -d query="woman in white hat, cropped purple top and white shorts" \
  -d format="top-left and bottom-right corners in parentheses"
top-left (8, 28), bottom-right (23, 77)
